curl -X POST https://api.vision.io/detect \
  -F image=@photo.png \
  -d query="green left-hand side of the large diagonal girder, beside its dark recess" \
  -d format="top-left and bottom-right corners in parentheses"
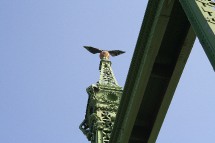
top-left (110, 0), bottom-right (166, 143)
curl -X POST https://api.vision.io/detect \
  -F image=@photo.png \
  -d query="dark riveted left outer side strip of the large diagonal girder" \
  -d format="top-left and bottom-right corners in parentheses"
top-left (110, 0), bottom-right (163, 143)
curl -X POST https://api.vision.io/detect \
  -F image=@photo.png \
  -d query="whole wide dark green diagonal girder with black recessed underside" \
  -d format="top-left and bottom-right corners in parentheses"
top-left (110, 0), bottom-right (196, 143)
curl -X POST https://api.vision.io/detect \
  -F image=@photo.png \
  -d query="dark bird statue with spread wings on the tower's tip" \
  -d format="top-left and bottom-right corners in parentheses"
top-left (84, 46), bottom-right (125, 59)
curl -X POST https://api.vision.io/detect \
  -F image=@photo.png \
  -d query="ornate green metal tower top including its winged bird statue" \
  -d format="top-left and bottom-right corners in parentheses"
top-left (79, 46), bottom-right (124, 143)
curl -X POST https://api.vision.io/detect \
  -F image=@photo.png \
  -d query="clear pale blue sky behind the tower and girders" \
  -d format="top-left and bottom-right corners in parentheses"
top-left (0, 0), bottom-right (215, 143)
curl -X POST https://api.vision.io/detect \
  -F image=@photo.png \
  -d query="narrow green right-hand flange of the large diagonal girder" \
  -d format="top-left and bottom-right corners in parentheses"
top-left (148, 28), bottom-right (196, 143)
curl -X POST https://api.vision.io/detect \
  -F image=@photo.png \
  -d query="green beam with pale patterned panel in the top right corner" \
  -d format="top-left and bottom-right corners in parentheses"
top-left (180, 0), bottom-right (215, 70)
